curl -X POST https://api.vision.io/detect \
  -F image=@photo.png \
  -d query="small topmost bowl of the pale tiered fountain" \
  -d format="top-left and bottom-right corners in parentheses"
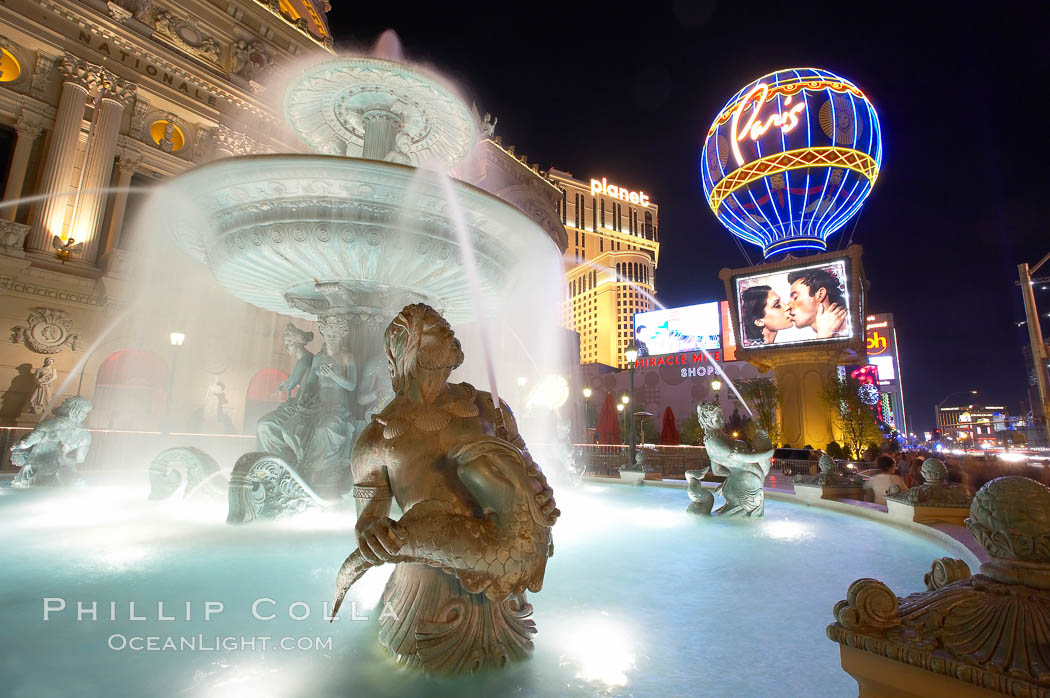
top-left (285, 57), bottom-right (478, 168)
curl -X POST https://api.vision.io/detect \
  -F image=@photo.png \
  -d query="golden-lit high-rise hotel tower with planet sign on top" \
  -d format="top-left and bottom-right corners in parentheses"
top-left (547, 168), bottom-right (659, 368)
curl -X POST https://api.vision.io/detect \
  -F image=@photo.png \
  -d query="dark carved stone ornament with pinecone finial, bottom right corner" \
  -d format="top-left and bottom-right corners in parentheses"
top-left (827, 477), bottom-right (1050, 697)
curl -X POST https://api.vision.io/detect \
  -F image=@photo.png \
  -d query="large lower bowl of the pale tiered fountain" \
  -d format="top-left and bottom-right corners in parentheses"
top-left (149, 154), bottom-right (558, 323)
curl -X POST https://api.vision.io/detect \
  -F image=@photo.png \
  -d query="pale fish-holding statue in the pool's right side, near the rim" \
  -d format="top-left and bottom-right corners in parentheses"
top-left (686, 402), bottom-right (773, 519)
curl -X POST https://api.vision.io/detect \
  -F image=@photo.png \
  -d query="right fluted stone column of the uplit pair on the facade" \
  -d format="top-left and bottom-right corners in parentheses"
top-left (69, 73), bottom-right (135, 263)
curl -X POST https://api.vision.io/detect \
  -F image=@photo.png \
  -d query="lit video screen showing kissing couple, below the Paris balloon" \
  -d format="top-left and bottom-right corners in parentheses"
top-left (733, 258), bottom-right (854, 348)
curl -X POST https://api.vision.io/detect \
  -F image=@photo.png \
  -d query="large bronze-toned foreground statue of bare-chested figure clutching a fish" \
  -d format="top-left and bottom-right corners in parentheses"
top-left (333, 303), bottom-right (560, 674)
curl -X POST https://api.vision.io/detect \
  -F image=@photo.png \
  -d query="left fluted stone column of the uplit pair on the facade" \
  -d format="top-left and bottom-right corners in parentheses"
top-left (27, 54), bottom-right (98, 252)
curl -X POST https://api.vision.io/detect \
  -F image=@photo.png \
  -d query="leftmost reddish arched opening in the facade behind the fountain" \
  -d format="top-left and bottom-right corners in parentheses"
top-left (89, 350), bottom-right (168, 431)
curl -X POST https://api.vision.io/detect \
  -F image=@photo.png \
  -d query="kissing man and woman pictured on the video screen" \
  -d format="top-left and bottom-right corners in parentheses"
top-left (740, 267), bottom-right (848, 346)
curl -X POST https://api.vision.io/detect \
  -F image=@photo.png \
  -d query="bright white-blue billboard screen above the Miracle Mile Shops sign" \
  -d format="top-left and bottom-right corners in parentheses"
top-left (634, 301), bottom-right (721, 356)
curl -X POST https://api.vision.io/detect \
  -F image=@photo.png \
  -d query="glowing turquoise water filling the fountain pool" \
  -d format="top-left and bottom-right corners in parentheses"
top-left (0, 484), bottom-right (950, 698)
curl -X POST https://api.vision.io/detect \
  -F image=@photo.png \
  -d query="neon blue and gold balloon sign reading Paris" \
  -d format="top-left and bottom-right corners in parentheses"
top-left (700, 68), bottom-right (882, 258)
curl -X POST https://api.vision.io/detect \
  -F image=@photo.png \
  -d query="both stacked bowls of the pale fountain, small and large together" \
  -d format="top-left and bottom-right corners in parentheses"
top-left (155, 38), bottom-right (559, 329)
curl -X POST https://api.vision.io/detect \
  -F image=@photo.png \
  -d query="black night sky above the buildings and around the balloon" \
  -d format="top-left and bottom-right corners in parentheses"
top-left (329, 1), bottom-right (1050, 431)
